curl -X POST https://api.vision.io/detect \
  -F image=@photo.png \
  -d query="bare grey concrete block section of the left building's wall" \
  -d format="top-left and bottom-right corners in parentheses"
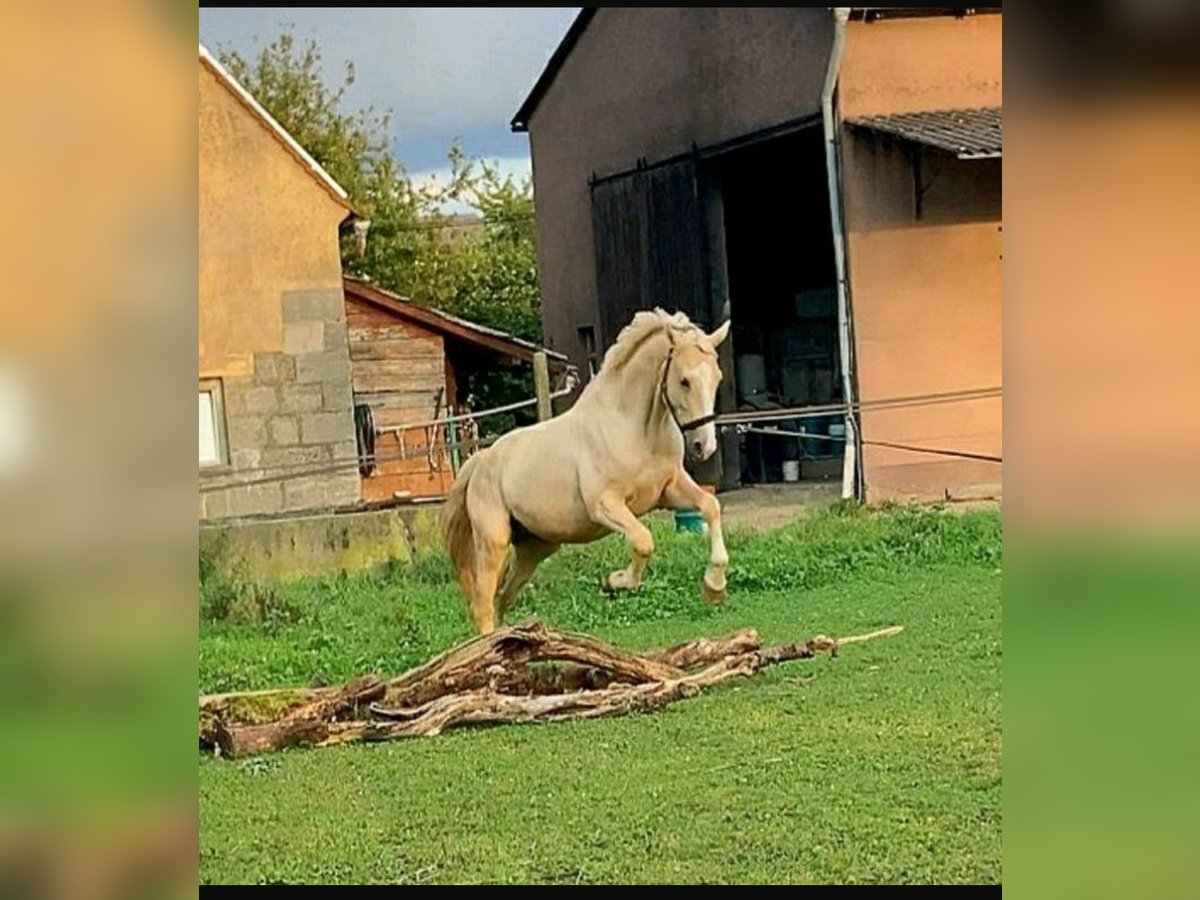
top-left (200, 289), bottom-right (361, 518)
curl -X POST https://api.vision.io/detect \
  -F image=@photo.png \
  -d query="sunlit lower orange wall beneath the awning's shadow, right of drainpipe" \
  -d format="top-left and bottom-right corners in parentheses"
top-left (851, 217), bottom-right (1002, 500)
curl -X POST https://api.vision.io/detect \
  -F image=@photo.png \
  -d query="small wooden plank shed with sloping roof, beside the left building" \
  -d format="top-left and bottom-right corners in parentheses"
top-left (343, 276), bottom-right (566, 503)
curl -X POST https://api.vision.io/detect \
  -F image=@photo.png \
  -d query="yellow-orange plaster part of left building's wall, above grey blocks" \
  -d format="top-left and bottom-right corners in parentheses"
top-left (199, 64), bottom-right (347, 378)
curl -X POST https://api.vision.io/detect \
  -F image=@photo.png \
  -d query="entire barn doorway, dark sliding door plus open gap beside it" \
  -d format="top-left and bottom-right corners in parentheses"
top-left (588, 120), bottom-right (844, 490)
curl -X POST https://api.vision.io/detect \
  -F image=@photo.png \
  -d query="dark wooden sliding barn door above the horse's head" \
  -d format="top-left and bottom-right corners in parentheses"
top-left (592, 160), bottom-right (710, 348)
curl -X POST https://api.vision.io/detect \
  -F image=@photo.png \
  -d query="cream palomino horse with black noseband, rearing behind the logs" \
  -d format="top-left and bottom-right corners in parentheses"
top-left (443, 310), bottom-right (730, 634)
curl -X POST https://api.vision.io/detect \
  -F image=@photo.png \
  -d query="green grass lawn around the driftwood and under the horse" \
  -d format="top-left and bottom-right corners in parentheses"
top-left (199, 510), bottom-right (1001, 883)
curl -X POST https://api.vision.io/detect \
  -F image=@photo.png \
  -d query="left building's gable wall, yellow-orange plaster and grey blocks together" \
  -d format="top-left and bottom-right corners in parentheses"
top-left (199, 59), bottom-right (361, 520)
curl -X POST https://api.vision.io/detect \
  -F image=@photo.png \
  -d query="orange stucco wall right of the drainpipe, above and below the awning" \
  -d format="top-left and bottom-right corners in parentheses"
top-left (839, 16), bottom-right (1002, 502)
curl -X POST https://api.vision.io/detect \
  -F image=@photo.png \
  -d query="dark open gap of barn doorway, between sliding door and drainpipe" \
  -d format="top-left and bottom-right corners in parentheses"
top-left (703, 125), bottom-right (844, 485)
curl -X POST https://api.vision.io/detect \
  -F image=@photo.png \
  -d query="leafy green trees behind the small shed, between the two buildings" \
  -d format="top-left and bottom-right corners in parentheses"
top-left (221, 31), bottom-right (541, 432)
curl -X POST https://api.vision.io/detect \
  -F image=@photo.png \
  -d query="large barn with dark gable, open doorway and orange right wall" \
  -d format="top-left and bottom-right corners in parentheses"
top-left (512, 7), bottom-right (1002, 502)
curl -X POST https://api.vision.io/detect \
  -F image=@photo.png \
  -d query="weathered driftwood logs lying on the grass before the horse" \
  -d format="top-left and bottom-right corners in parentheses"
top-left (200, 620), bottom-right (902, 757)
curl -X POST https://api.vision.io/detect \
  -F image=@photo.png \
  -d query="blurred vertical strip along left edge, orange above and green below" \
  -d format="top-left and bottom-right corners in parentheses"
top-left (0, 1), bottom-right (197, 896)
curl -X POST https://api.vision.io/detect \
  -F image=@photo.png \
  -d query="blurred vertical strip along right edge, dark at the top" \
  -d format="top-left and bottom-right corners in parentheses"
top-left (1003, 7), bottom-right (1200, 896)
